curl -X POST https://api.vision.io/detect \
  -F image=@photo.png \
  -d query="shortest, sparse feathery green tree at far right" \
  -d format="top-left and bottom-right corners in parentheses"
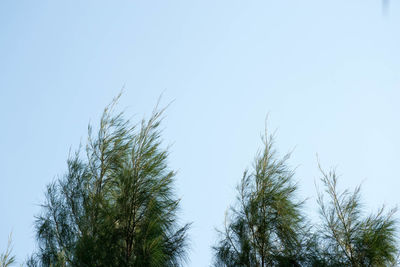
top-left (318, 167), bottom-right (398, 267)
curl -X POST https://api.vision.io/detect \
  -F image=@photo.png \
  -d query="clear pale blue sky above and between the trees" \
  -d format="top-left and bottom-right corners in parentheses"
top-left (0, 0), bottom-right (400, 267)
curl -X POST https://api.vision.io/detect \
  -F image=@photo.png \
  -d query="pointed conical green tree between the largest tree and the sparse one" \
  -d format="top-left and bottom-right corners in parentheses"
top-left (214, 129), bottom-right (311, 267)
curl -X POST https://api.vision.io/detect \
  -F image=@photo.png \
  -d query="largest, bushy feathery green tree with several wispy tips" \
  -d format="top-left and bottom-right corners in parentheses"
top-left (28, 96), bottom-right (189, 266)
